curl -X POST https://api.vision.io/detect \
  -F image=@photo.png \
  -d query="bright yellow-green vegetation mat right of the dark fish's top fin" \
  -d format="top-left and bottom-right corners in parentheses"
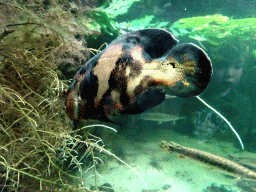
top-left (170, 14), bottom-right (256, 46)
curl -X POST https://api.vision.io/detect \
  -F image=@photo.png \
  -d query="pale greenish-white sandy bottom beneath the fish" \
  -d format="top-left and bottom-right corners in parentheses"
top-left (81, 130), bottom-right (247, 192)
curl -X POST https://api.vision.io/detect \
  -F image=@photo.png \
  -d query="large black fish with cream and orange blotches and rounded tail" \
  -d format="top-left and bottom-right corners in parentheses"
top-left (66, 29), bottom-right (212, 121)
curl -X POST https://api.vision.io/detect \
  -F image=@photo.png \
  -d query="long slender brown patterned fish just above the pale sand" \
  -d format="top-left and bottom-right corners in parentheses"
top-left (159, 141), bottom-right (256, 180)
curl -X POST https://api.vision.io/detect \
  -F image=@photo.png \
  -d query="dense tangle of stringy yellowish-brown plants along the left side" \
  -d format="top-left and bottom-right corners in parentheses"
top-left (0, 0), bottom-right (121, 191)
